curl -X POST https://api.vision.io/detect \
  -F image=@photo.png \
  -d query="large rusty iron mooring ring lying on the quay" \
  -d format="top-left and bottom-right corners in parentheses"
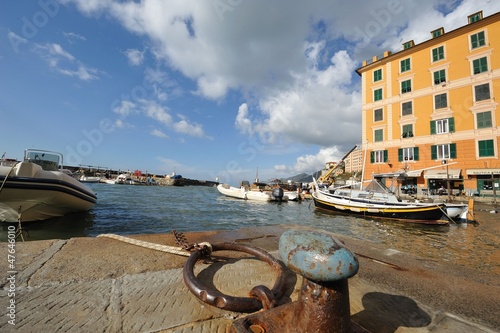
top-left (182, 242), bottom-right (286, 312)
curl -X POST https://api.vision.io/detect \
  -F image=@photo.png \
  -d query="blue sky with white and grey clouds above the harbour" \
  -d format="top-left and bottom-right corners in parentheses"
top-left (0, 0), bottom-right (500, 184)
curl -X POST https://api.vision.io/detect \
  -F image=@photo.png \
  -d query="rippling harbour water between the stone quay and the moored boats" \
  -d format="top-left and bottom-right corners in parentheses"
top-left (0, 184), bottom-right (500, 274)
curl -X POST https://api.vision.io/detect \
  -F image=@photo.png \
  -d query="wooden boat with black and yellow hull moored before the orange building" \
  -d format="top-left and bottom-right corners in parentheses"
top-left (312, 178), bottom-right (448, 224)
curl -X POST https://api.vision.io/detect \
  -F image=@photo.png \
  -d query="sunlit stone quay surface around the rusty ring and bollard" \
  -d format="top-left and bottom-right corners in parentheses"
top-left (0, 225), bottom-right (500, 333)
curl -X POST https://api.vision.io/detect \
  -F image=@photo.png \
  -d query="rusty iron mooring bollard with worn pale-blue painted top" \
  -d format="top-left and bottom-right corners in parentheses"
top-left (231, 230), bottom-right (362, 333)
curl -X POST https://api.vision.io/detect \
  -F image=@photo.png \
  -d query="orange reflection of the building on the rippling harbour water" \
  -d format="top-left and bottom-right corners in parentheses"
top-left (315, 211), bottom-right (500, 274)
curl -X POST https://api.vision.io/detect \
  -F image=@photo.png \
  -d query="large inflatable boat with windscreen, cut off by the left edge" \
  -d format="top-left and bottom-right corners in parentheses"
top-left (0, 149), bottom-right (97, 222)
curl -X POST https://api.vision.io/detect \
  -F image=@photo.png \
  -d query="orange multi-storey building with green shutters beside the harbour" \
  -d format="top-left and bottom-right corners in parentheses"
top-left (356, 12), bottom-right (500, 195)
